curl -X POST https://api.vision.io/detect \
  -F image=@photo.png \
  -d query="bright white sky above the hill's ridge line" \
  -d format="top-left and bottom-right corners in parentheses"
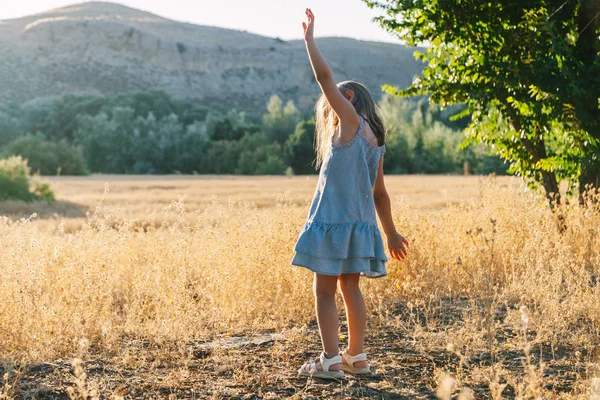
top-left (0, 0), bottom-right (398, 43)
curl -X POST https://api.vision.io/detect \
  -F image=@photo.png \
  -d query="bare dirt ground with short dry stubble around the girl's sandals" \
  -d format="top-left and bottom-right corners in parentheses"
top-left (4, 303), bottom-right (593, 399)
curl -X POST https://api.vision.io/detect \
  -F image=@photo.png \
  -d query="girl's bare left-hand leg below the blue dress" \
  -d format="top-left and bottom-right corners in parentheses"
top-left (305, 274), bottom-right (341, 371)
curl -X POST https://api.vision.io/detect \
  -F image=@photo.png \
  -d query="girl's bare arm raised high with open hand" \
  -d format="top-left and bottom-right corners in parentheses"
top-left (302, 8), bottom-right (360, 127)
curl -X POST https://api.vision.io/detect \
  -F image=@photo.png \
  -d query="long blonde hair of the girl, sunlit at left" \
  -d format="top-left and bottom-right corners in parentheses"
top-left (314, 81), bottom-right (385, 169)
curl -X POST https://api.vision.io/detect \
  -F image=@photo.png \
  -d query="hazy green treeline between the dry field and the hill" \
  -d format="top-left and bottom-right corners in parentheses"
top-left (0, 91), bottom-right (506, 175)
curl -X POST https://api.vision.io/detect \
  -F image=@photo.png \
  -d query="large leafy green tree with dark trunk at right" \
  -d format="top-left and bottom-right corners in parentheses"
top-left (365, 0), bottom-right (600, 205)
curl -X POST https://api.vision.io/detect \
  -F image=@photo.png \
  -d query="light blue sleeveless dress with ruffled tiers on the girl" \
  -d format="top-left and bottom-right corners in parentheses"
top-left (291, 116), bottom-right (388, 278)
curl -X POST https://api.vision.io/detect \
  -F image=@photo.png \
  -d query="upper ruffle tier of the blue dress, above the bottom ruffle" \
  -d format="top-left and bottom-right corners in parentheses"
top-left (294, 221), bottom-right (388, 261)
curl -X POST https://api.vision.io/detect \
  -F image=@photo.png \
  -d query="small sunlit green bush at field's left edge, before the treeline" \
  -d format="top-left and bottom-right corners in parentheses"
top-left (0, 156), bottom-right (55, 203)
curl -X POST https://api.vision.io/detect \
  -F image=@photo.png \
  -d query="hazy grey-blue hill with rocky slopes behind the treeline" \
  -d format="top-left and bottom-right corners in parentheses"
top-left (0, 2), bottom-right (421, 107)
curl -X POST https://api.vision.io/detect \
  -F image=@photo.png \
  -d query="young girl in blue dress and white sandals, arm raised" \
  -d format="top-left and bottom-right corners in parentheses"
top-left (291, 8), bottom-right (408, 378)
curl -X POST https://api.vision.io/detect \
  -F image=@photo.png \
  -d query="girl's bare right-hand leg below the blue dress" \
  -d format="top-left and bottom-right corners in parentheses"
top-left (339, 273), bottom-right (367, 368)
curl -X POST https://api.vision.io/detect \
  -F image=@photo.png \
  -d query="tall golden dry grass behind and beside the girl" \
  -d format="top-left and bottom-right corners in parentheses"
top-left (0, 176), bottom-right (600, 398)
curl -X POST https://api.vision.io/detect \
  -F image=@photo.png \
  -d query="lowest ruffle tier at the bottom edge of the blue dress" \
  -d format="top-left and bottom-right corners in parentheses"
top-left (291, 252), bottom-right (387, 278)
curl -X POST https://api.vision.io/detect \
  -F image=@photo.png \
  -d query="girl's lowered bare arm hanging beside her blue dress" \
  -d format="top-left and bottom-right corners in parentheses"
top-left (373, 156), bottom-right (408, 261)
